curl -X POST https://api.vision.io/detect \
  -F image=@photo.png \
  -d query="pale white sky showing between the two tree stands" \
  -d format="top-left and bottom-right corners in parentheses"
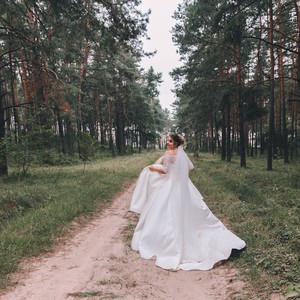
top-left (139, 0), bottom-right (182, 111)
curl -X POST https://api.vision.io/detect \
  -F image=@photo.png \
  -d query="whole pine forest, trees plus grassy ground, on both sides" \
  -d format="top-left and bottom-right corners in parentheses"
top-left (0, 0), bottom-right (300, 300)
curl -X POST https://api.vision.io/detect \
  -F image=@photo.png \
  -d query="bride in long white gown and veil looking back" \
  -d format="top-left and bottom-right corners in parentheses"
top-left (130, 134), bottom-right (246, 270)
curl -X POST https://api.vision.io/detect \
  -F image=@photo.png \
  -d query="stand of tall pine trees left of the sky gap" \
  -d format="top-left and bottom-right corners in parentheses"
top-left (0, 0), bottom-right (168, 175)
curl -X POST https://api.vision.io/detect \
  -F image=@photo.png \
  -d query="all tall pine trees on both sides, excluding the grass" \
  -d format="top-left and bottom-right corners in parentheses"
top-left (0, 0), bottom-right (300, 175)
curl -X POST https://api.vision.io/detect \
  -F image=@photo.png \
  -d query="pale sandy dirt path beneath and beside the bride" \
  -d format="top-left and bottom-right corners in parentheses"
top-left (0, 185), bottom-right (248, 300)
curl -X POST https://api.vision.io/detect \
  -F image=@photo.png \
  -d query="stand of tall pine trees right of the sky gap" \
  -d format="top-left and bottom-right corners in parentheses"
top-left (172, 0), bottom-right (300, 170)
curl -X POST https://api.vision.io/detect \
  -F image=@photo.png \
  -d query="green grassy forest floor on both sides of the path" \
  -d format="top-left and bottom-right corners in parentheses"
top-left (0, 152), bottom-right (300, 299)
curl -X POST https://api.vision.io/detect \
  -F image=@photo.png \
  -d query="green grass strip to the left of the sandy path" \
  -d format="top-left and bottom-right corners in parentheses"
top-left (0, 152), bottom-right (159, 288)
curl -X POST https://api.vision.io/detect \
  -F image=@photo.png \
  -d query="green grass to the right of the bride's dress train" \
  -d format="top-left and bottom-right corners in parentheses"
top-left (191, 154), bottom-right (300, 299)
